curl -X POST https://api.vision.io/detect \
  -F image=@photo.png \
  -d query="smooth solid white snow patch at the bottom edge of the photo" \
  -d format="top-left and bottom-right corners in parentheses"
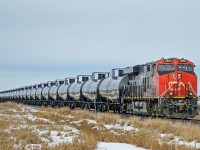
top-left (96, 142), bottom-right (145, 150)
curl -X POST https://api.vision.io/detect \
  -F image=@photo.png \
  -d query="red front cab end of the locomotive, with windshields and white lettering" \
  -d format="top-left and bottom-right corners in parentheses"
top-left (154, 58), bottom-right (198, 118)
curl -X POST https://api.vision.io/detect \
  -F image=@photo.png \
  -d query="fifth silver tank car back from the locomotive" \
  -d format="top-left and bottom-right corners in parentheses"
top-left (49, 80), bottom-right (64, 101)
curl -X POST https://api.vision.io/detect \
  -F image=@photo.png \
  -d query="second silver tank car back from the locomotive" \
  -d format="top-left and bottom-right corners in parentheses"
top-left (82, 72), bottom-right (109, 102)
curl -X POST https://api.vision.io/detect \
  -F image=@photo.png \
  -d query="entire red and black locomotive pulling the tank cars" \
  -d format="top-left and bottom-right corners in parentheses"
top-left (123, 58), bottom-right (198, 118)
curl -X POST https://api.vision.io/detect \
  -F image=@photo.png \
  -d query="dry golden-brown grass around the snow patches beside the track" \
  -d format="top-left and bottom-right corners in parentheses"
top-left (0, 103), bottom-right (200, 150)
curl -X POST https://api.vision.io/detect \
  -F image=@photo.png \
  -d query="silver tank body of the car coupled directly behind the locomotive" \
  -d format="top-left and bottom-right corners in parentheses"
top-left (99, 69), bottom-right (129, 103)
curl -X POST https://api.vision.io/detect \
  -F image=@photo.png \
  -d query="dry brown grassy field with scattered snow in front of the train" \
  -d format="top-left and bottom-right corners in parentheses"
top-left (0, 102), bottom-right (200, 150)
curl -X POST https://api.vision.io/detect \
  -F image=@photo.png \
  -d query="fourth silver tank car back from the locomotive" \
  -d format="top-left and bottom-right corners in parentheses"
top-left (58, 78), bottom-right (76, 101)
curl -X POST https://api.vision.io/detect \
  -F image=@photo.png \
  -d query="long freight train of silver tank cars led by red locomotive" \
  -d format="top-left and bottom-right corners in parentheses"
top-left (0, 58), bottom-right (198, 118)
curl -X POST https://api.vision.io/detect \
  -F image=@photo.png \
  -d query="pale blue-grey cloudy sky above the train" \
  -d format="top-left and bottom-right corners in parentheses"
top-left (0, 0), bottom-right (200, 94)
